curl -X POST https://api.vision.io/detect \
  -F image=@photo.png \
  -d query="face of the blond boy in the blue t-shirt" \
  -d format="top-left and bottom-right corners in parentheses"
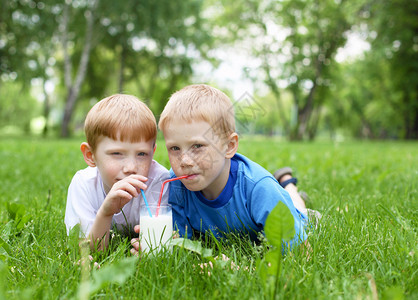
top-left (164, 121), bottom-right (230, 199)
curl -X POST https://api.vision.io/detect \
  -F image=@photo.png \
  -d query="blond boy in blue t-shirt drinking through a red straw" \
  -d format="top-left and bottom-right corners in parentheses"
top-left (154, 84), bottom-right (314, 247)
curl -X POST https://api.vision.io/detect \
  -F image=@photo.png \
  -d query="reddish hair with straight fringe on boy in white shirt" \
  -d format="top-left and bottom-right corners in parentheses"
top-left (84, 94), bottom-right (157, 151)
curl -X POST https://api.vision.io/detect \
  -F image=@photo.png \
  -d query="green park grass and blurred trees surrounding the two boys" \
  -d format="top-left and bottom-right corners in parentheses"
top-left (0, 0), bottom-right (418, 299)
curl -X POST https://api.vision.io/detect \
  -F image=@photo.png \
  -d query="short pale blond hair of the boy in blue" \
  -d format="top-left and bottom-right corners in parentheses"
top-left (158, 84), bottom-right (235, 137)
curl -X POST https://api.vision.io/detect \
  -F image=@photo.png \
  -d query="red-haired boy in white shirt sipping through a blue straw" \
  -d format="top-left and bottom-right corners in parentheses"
top-left (65, 94), bottom-right (169, 249)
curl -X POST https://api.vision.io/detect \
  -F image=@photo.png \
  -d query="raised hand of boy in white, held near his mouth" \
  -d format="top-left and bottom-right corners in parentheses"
top-left (98, 175), bottom-right (148, 216)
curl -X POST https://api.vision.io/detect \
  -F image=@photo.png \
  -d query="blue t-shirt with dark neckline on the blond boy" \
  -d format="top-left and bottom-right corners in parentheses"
top-left (168, 154), bottom-right (307, 247)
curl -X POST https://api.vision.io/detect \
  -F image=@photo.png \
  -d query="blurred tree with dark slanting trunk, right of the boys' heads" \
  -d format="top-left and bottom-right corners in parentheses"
top-left (254, 0), bottom-right (361, 140)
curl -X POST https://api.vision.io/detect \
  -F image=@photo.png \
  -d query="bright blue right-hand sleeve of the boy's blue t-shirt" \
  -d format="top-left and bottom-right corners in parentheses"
top-left (249, 177), bottom-right (307, 248)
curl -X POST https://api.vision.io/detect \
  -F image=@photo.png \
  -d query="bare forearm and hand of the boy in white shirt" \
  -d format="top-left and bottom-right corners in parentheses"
top-left (89, 175), bottom-right (147, 250)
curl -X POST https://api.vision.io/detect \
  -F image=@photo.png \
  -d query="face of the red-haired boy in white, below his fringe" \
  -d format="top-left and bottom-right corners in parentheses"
top-left (93, 137), bottom-right (155, 193)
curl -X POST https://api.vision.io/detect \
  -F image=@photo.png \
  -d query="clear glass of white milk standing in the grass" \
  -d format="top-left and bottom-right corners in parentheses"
top-left (139, 205), bottom-right (173, 252)
